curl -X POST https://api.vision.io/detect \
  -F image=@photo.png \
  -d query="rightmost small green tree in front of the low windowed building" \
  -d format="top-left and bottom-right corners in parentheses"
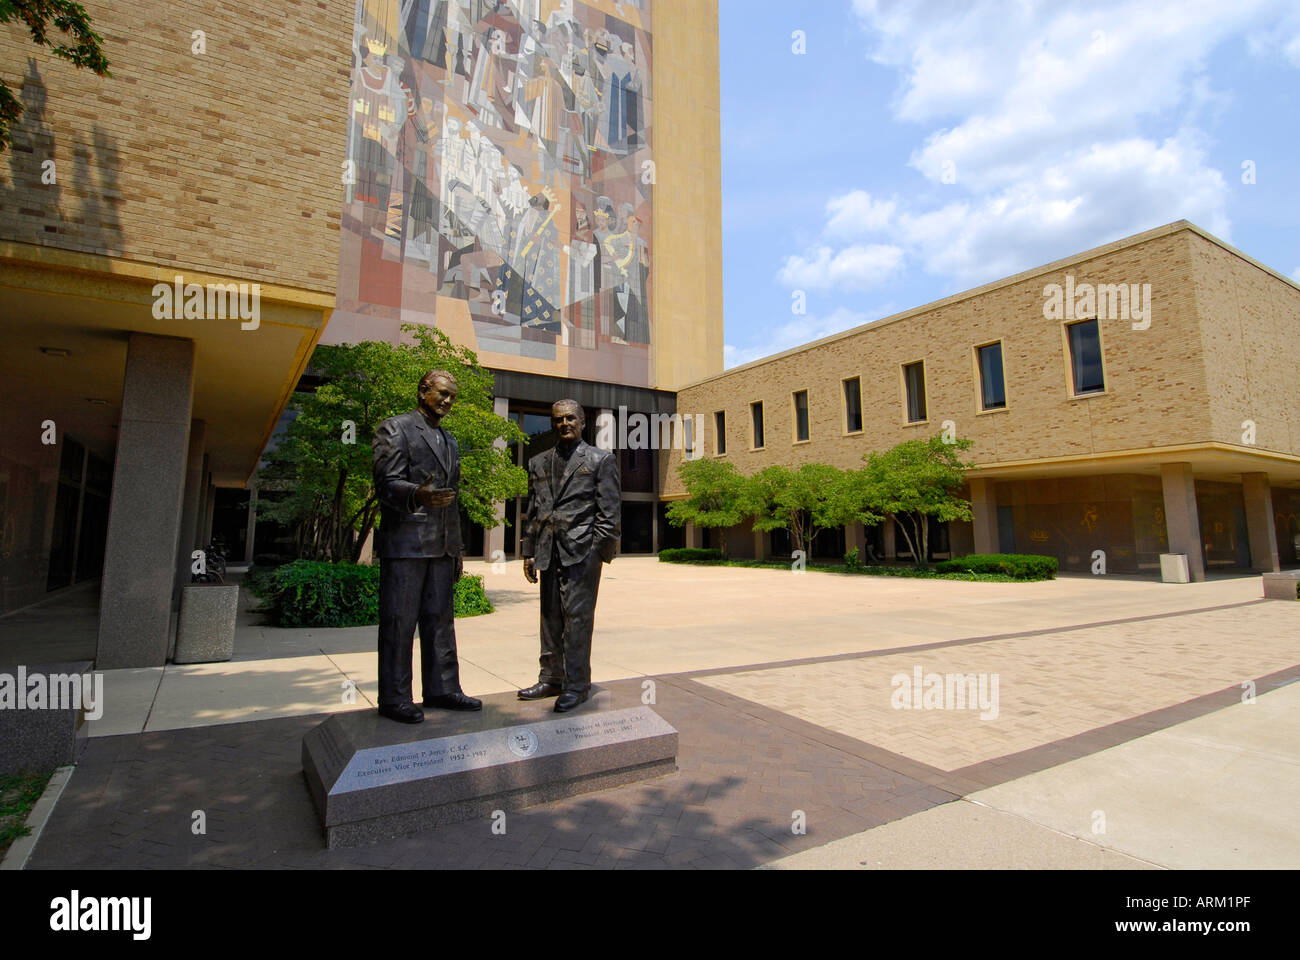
top-left (862, 436), bottom-right (972, 567)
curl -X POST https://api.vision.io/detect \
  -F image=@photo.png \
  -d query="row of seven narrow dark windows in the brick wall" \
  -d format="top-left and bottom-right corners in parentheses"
top-left (714, 320), bottom-right (1106, 457)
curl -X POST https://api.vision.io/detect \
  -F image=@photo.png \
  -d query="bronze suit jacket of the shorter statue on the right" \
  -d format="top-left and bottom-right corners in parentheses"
top-left (519, 441), bottom-right (623, 570)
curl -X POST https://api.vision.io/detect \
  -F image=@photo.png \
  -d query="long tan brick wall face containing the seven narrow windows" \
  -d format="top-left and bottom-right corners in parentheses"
top-left (662, 228), bottom-right (1237, 497)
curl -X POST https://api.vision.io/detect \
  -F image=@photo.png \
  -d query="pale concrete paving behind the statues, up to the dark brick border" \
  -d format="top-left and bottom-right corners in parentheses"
top-left (90, 558), bottom-right (1260, 736)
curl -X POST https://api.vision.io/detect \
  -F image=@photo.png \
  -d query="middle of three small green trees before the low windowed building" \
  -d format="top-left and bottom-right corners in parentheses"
top-left (744, 463), bottom-right (852, 557)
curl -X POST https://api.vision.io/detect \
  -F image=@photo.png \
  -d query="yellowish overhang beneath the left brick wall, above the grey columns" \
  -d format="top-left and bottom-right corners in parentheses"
top-left (0, 242), bottom-right (334, 487)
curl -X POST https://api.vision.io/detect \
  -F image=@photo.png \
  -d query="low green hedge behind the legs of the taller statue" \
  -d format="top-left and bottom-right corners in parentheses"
top-left (251, 561), bottom-right (493, 627)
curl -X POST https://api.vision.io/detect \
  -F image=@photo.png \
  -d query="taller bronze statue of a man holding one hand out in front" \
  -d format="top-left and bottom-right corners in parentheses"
top-left (373, 371), bottom-right (482, 723)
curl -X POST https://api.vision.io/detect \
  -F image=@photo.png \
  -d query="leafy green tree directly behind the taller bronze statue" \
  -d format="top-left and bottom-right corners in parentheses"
top-left (257, 324), bottom-right (528, 562)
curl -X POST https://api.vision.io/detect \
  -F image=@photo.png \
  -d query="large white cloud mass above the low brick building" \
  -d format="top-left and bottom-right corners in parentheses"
top-left (779, 0), bottom-right (1279, 290)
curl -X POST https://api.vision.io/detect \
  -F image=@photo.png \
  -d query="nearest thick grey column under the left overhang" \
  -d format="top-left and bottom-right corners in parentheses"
top-left (95, 333), bottom-right (194, 670)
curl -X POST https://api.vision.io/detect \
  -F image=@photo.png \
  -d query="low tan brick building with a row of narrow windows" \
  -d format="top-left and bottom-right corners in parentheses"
top-left (662, 221), bottom-right (1300, 580)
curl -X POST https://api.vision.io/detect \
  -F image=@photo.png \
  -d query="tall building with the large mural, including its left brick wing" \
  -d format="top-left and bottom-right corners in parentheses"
top-left (0, 0), bottom-right (723, 669)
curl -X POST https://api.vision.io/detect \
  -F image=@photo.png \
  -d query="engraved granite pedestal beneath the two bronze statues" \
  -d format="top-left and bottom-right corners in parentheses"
top-left (303, 691), bottom-right (677, 848)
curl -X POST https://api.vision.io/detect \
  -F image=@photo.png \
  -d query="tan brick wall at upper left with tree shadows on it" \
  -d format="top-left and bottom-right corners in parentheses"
top-left (0, 0), bottom-right (352, 295)
